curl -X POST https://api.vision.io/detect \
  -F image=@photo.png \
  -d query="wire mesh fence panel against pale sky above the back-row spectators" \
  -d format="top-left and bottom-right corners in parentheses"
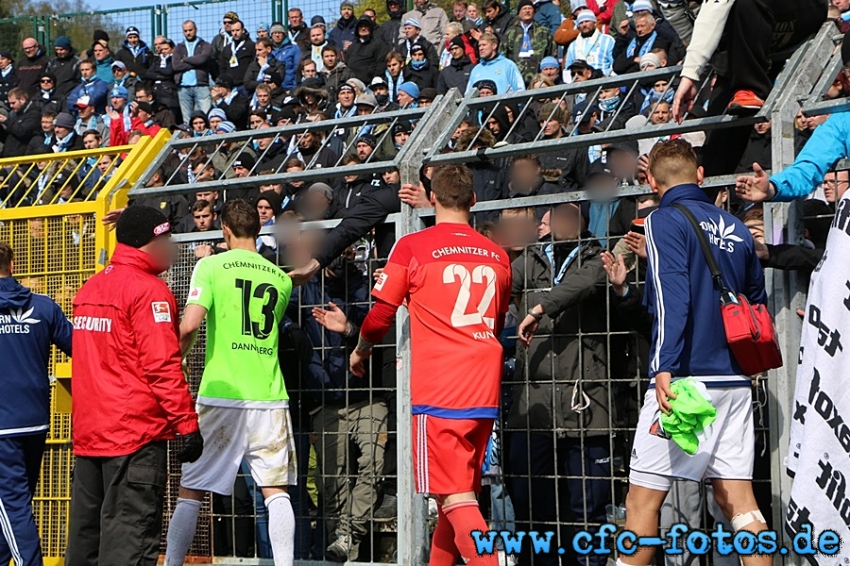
top-left (162, 0), bottom-right (277, 47)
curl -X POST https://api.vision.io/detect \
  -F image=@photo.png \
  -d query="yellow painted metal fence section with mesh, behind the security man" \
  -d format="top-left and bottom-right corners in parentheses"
top-left (0, 129), bottom-right (170, 566)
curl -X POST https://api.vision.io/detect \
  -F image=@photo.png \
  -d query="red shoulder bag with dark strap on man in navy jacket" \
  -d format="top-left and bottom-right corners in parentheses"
top-left (673, 204), bottom-right (782, 375)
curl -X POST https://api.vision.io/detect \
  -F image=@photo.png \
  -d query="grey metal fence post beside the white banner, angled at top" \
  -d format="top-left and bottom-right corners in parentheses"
top-left (764, 26), bottom-right (834, 564)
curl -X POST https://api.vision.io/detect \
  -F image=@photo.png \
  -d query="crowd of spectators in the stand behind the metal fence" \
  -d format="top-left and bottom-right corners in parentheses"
top-left (0, 0), bottom-right (850, 564)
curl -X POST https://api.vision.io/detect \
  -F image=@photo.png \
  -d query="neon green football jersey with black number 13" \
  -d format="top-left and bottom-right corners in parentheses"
top-left (187, 250), bottom-right (292, 408)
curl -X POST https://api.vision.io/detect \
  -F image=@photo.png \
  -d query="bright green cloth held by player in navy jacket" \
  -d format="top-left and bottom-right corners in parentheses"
top-left (661, 377), bottom-right (717, 455)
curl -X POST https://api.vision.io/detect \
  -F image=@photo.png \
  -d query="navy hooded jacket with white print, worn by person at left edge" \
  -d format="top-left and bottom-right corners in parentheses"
top-left (0, 277), bottom-right (72, 437)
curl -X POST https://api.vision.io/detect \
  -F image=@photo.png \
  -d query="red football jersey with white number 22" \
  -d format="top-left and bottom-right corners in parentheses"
top-left (372, 223), bottom-right (511, 419)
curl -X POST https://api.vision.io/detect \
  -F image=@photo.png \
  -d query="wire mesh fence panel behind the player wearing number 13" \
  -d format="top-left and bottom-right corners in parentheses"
top-left (163, 219), bottom-right (398, 563)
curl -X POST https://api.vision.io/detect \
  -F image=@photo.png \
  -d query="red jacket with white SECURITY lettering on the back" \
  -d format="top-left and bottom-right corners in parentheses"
top-left (72, 244), bottom-right (198, 457)
